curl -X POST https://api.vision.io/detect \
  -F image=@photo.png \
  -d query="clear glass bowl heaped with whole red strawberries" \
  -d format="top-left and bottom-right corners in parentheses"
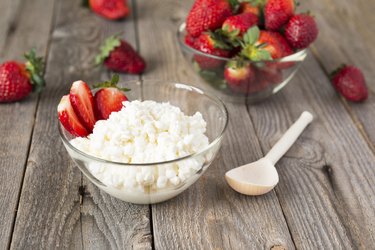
top-left (177, 0), bottom-right (318, 102)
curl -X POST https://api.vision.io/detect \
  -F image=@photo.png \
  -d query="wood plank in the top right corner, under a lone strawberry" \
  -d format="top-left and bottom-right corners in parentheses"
top-left (303, 0), bottom-right (375, 153)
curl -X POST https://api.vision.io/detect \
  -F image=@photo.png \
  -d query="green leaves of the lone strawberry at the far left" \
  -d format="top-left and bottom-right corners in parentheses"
top-left (25, 48), bottom-right (46, 93)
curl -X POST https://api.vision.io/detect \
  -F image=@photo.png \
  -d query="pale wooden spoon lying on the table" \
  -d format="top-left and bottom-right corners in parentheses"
top-left (225, 111), bottom-right (313, 195)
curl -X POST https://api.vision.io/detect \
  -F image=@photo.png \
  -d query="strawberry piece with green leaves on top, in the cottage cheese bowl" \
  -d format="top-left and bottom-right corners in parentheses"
top-left (94, 75), bottom-right (128, 120)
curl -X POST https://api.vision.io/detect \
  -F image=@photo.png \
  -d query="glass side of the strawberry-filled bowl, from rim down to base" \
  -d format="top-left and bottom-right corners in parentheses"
top-left (177, 23), bottom-right (307, 103)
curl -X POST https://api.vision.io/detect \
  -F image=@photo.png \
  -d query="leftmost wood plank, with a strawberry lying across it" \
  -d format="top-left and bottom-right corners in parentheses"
top-left (0, 0), bottom-right (54, 249)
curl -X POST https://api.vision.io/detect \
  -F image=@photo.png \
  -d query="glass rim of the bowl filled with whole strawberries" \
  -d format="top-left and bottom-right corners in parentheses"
top-left (176, 22), bottom-right (308, 63)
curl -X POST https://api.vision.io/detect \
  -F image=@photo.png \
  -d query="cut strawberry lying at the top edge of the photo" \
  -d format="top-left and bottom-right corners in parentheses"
top-left (89, 0), bottom-right (130, 20)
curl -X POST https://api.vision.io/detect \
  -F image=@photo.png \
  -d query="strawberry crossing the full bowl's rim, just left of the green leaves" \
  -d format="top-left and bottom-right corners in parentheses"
top-left (194, 32), bottom-right (231, 70)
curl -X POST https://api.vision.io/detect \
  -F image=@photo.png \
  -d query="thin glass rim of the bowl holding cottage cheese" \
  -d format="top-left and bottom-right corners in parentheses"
top-left (57, 79), bottom-right (229, 167)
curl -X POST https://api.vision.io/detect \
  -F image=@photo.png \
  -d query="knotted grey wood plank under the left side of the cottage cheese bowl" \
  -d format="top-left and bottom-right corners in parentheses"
top-left (12, 0), bottom-right (151, 249)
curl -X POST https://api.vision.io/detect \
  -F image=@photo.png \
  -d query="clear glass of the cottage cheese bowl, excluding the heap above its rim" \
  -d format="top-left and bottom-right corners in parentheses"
top-left (59, 80), bottom-right (228, 204)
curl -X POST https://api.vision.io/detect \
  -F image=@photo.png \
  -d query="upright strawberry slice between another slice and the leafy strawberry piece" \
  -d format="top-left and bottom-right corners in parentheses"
top-left (69, 81), bottom-right (96, 132)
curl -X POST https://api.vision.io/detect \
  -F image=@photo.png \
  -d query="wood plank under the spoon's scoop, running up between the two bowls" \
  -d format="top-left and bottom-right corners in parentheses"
top-left (137, 0), bottom-right (294, 249)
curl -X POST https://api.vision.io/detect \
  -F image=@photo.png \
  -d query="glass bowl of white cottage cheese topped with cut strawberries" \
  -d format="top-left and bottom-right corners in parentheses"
top-left (58, 77), bottom-right (228, 204)
